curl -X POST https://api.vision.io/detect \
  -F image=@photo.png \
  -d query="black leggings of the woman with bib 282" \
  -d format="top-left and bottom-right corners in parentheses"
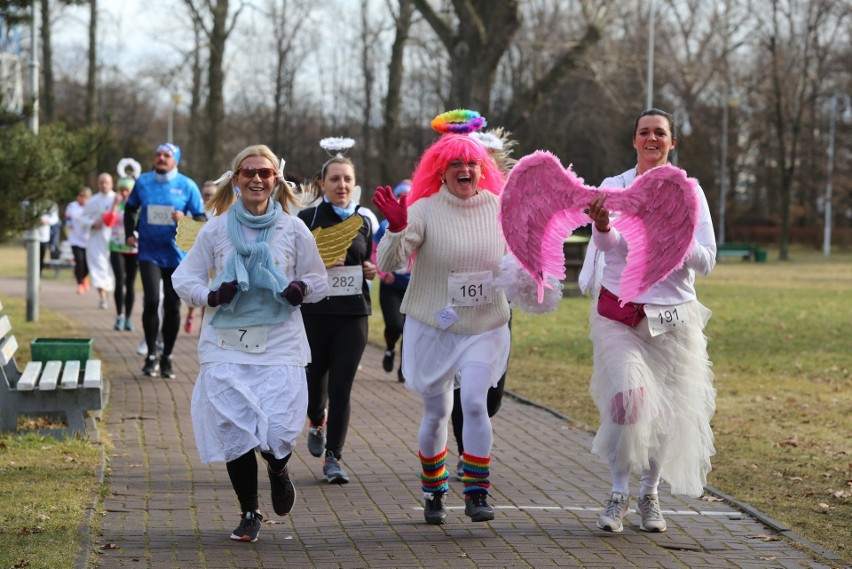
top-left (305, 314), bottom-right (367, 459)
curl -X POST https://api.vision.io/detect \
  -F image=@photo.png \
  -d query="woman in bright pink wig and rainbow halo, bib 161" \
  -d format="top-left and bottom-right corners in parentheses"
top-left (374, 110), bottom-right (509, 524)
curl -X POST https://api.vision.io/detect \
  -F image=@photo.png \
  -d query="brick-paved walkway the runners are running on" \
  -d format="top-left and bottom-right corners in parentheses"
top-left (0, 279), bottom-right (830, 569)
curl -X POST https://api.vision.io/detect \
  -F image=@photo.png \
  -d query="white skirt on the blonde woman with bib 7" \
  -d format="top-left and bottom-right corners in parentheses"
top-left (190, 362), bottom-right (308, 463)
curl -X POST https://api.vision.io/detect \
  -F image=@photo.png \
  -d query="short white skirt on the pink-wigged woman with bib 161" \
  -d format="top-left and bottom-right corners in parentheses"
top-left (402, 316), bottom-right (510, 397)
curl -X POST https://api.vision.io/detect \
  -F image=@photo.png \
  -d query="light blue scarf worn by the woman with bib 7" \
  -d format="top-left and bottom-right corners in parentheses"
top-left (210, 199), bottom-right (296, 328)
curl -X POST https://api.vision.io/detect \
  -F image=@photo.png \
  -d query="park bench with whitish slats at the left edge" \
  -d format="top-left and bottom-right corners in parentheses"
top-left (0, 304), bottom-right (103, 438)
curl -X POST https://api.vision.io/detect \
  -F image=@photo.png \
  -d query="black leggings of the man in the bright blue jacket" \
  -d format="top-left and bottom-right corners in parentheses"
top-left (139, 261), bottom-right (180, 356)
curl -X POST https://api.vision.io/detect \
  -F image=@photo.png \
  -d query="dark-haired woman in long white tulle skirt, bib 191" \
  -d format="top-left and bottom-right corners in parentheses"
top-left (580, 109), bottom-right (716, 532)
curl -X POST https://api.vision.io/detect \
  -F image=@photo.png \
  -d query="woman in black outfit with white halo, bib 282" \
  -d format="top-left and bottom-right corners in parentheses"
top-left (299, 146), bottom-right (376, 484)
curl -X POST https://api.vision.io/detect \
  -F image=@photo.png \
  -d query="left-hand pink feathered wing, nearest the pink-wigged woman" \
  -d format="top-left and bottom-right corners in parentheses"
top-left (500, 150), bottom-right (597, 302)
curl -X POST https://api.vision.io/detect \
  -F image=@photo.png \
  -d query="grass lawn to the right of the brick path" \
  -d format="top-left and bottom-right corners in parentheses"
top-left (370, 243), bottom-right (852, 563)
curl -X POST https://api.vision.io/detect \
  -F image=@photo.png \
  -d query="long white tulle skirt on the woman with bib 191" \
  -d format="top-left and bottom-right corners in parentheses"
top-left (589, 301), bottom-right (716, 496)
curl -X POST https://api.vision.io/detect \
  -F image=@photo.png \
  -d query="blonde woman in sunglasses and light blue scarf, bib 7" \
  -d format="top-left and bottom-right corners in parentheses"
top-left (172, 145), bottom-right (328, 542)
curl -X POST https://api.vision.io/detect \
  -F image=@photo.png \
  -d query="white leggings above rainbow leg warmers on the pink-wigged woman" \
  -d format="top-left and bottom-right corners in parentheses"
top-left (418, 363), bottom-right (494, 457)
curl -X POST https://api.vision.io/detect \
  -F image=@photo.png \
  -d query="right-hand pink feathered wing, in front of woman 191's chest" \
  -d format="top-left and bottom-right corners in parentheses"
top-left (600, 165), bottom-right (699, 303)
